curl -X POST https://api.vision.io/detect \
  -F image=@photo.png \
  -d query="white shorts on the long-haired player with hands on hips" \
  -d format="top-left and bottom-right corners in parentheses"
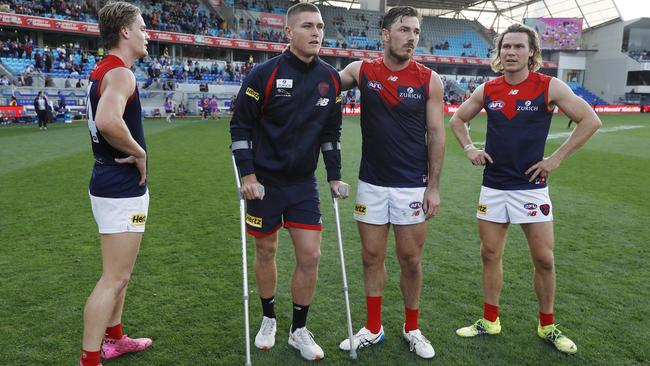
top-left (476, 186), bottom-right (553, 224)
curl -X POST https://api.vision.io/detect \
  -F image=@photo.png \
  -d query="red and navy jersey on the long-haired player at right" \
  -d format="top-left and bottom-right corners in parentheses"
top-left (483, 72), bottom-right (553, 190)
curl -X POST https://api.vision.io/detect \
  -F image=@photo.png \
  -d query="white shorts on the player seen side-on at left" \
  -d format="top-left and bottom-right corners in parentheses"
top-left (88, 189), bottom-right (149, 234)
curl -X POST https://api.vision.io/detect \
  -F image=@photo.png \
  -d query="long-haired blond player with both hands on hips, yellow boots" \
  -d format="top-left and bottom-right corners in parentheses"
top-left (450, 24), bottom-right (601, 354)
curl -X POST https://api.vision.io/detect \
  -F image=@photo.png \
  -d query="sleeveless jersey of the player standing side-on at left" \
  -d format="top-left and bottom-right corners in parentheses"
top-left (86, 55), bottom-right (147, 198)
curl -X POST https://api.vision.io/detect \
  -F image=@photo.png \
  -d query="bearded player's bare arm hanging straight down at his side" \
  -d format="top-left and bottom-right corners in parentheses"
top-left (422, 72), bottom-right (445, 219)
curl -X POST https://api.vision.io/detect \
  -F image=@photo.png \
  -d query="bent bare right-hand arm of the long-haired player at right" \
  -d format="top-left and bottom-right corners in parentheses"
top-left (526, 78), bottom-right (602, 182)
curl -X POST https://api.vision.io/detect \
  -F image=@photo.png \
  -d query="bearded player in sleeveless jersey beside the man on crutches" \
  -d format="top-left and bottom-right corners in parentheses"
top-left (339, 6), bottom-right (445, 358)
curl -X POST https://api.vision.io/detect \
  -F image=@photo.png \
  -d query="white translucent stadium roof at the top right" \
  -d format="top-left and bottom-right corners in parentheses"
top-left (311, 0), bottom-right (621, 32)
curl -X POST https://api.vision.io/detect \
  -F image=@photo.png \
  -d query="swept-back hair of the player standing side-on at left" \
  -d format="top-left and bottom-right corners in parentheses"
top-left (97, 1), bottom-right (141, 50)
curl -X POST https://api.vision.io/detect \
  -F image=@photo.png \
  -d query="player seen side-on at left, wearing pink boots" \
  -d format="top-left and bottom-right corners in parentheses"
top-left (79, 1), bottom-right (152, 366)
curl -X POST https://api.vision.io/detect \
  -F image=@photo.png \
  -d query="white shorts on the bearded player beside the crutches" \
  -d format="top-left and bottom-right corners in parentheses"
top-left (354, 180), bottom-right (426, 225)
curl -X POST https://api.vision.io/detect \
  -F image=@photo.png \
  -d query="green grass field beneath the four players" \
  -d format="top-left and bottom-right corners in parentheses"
top-left (0, 115), bottom-right (650, 366)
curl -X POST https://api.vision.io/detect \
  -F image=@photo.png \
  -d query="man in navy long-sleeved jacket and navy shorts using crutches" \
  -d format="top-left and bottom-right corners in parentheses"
top-left (230, 3), bottom-right (342, 360)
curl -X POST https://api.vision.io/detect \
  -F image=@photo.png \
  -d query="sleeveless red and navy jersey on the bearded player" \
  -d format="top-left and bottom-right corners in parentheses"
top-left (359, 58), bottom-right (431, 188)
